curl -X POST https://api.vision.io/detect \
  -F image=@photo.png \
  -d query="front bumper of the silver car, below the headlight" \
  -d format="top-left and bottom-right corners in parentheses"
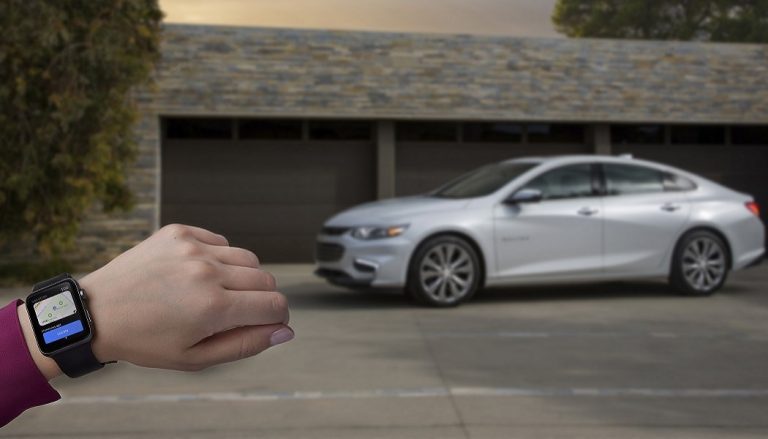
top-left (315, 233), bottom-right (413, 287)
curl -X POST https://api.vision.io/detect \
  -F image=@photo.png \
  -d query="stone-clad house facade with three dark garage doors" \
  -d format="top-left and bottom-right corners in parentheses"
top-left (58, 25), bottom-right (768, 268)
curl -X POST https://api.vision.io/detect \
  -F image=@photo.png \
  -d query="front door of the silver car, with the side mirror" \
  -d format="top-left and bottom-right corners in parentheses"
top-left (494, 163), bottom-right (603, 280)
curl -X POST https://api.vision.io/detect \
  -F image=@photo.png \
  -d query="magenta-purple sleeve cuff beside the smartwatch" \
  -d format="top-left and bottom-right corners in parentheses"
top-left (0, 300), bottom-right (60, 427)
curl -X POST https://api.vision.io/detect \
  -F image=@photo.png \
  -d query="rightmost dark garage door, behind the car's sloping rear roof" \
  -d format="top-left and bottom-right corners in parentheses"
top-left (611, 125), bottom-right (768, 230)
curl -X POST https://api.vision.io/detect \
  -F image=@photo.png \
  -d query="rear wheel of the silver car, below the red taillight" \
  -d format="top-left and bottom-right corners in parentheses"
top-left (670, 230), bottom-right (728, 296)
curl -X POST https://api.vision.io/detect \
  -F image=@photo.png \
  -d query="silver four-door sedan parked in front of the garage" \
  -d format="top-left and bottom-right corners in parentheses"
top-left (316, 155), bottom-right (765, 306)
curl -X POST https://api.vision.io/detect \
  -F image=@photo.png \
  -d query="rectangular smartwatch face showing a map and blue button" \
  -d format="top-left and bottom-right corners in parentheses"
top-left (26, 280), bottom-right (91, 355)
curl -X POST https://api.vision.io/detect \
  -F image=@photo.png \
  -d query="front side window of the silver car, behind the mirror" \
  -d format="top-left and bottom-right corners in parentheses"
top-left (524, 163), bottom-right (594, 200)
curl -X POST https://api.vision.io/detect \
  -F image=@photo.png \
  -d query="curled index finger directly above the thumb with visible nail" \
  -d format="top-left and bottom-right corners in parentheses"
top-left (216, 291), bottom-right (290, 331)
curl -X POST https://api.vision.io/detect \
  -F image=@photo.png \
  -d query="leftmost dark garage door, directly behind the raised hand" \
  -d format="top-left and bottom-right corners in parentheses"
top-left (161, 117), bottom-right (375, 263)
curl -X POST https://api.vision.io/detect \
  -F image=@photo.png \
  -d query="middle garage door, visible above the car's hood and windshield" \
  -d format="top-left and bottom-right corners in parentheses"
top-left (395, 122), bottom-right (591, 195)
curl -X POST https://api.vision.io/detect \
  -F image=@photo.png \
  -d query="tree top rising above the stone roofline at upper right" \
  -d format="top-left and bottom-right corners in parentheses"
top-left (552, 0), bottom-right (768, 43)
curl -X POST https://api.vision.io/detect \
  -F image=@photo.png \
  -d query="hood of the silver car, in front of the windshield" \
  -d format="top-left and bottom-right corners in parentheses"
top-left (326, 195), bottom-right (469, 227)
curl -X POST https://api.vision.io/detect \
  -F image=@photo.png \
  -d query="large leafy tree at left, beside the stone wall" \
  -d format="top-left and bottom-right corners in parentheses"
top-left (0, 0), bottom-right (162, 255)
